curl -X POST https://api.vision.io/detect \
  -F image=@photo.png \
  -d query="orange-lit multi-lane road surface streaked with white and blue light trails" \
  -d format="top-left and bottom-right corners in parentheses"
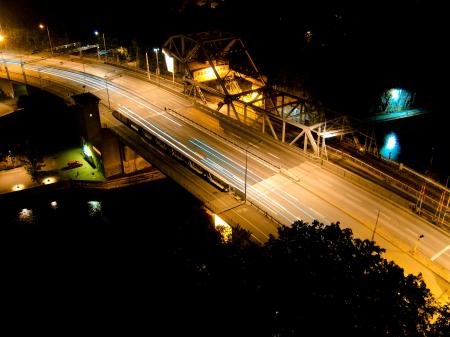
top-left (2, 50), bottom-right (450, 300)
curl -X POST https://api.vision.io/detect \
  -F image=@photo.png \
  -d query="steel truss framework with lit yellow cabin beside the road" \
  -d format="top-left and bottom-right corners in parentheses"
top-left (163, 32), bottom-right (353, 155)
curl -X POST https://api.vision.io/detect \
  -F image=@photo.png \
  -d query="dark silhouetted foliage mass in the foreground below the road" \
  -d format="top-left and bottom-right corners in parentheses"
top-left (147, 217), bottom-right (449, 337)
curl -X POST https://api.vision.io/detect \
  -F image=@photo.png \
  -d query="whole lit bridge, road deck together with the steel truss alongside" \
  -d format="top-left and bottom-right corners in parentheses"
top-left (0, 36), bottom-right (450, 296)
